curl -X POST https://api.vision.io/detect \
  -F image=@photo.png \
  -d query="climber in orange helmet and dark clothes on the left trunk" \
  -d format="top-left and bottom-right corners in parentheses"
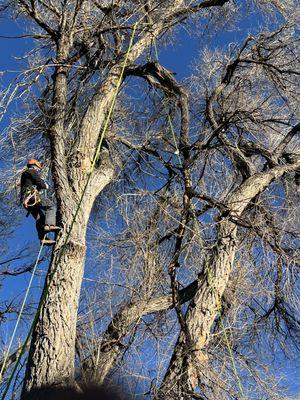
top-left (21, 159), bottom-right (61, 246)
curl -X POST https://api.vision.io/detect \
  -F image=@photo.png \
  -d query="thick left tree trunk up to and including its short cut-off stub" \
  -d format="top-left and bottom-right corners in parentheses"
top-left (21, 165), bottom-right (114, 398)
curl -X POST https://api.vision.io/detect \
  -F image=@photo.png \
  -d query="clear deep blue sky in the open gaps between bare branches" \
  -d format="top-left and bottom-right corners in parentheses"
top-left (0, 5), bottom-right (300, 394)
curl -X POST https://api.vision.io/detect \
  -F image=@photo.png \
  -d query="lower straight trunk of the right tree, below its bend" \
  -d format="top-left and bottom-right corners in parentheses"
top-left (160, 219), bottom-right (237, 400)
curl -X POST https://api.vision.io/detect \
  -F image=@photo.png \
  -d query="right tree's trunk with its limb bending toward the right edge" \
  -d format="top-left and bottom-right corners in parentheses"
top-left (159, 160), bottom-right (300, 400)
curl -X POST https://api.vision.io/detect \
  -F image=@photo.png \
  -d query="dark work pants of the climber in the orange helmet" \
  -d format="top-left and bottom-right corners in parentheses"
top-left (28, 198), bottom-right (56, 240)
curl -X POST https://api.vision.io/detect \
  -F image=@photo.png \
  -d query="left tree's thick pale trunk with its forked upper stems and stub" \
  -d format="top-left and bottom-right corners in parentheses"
top-left (20, 0), bottom-right (231, 394)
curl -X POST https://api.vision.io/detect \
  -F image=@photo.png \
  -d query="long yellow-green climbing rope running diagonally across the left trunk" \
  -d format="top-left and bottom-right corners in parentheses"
top-left (0, 21), bottom-right (139, 400)
